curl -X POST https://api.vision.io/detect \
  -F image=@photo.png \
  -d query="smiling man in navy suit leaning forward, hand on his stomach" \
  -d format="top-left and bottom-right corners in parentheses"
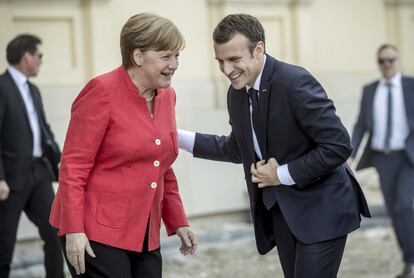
top-left (179, 14), bottom-right (370, 278)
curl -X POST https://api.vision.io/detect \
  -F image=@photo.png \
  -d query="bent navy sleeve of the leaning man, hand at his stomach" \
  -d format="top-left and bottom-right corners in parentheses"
top-left (288, 72), bottom-right (352, 188)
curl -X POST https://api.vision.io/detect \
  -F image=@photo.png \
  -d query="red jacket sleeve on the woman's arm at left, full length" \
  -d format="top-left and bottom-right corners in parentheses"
top-left (59, 80), bottom-right (110, 233)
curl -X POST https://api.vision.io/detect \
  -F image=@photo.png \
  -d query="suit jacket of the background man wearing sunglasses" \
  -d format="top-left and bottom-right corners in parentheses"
top-left (351, 76), bottom-right (414, 170)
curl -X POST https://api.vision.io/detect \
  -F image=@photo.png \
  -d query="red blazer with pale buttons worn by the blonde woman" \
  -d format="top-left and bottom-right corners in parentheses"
top-left (50, 66), bottom-right (188, 252)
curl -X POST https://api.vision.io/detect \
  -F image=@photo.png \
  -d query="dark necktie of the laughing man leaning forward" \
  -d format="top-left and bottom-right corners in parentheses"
top-left (249, 88), bottom-right (277, 210)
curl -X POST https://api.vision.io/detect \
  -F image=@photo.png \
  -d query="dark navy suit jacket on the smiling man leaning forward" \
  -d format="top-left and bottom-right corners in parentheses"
top-left (194, 56), bottom-right (369, 254)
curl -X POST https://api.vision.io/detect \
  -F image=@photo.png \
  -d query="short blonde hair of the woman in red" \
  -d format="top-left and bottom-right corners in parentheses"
top-left (120, 13), bottom-right (185, 69)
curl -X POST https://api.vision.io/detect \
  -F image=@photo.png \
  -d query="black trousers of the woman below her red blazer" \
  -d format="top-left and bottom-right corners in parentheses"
top-left (60, 230), bottom-right (162, 278)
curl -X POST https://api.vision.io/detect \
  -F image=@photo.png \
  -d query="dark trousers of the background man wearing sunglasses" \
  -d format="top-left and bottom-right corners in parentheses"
top-left (372, 151), bottom-right (414, 263)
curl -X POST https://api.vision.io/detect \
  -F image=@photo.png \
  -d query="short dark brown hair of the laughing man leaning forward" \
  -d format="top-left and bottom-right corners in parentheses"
top-left (213, 14), bottom-right (265, 53)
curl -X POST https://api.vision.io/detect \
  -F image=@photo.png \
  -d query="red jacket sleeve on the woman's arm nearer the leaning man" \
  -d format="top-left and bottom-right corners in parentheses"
top-left (162, 167), bottom-right (188, 235)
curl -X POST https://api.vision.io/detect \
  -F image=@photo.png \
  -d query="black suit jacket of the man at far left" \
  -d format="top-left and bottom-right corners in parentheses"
top-left (0, 71), bottom-right (60, 190)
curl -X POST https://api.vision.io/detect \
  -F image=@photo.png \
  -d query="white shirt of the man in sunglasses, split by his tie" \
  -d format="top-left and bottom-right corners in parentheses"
top-left (371, 73), bottom-right (409, 151)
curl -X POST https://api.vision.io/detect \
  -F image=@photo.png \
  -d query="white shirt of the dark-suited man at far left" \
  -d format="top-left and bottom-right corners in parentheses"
top-left (7, 65), bottom-right (43, 157)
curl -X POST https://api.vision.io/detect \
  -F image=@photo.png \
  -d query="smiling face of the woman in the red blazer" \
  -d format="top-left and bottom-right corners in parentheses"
top-left (137, 50), bottom-right (180, 89)
